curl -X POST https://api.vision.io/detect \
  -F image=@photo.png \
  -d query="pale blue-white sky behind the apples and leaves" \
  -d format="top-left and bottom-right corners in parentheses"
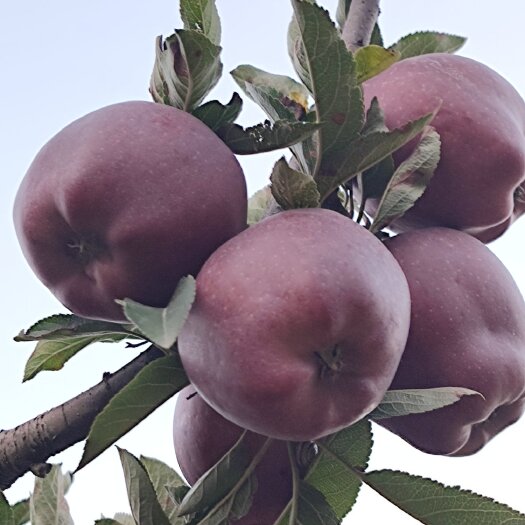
top-left (0, 0), bottom-right (525, 525)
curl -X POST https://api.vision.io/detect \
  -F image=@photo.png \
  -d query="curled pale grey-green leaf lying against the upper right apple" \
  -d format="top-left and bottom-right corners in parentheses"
top-left (370, 126), bottom-right (441, 233)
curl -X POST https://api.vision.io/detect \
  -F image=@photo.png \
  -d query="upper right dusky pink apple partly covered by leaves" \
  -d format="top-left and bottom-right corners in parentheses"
top-left (363, 53), bottom-right (525, 242)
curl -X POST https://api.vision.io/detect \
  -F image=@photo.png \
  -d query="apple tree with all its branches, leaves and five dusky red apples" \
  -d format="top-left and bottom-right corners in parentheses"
top-left (0, 0), bottom-right (525, 525)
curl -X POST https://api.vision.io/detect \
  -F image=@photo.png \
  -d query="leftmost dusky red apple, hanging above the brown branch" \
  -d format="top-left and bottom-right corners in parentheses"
top-left (14, 101), bottom-right (246, 321)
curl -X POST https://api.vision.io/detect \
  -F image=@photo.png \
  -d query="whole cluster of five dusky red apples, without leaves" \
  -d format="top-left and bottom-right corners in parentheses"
top-left (14, 54), bottom-right (525, 525)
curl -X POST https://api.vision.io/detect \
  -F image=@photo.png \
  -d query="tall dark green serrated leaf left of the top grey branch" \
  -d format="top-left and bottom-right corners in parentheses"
top-left (290, 0), bottom-right (364, 178)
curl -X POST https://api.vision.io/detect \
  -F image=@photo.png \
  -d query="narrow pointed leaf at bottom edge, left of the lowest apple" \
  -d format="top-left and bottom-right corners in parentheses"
top-left (117, 447), bottom-right (170, 525)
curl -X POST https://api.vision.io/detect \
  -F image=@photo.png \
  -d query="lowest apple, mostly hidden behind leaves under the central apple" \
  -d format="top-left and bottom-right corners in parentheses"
top-left (173, 385), bottom-right (292, 525)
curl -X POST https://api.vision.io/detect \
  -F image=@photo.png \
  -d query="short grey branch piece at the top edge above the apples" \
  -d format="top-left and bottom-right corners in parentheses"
top-left (342, 0), bottom-right (379, 52)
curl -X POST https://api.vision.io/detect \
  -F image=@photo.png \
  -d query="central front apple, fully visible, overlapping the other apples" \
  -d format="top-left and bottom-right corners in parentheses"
top-left (178, 209), bottom-right (410, 441)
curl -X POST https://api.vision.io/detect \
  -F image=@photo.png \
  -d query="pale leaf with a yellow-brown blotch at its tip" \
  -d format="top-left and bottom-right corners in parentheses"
top-left (231, 65), bottom-right (309, 122)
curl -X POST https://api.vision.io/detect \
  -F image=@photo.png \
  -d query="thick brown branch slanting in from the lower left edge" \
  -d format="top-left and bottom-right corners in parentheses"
top-left (0, 346), bottom-right (165, 490)
